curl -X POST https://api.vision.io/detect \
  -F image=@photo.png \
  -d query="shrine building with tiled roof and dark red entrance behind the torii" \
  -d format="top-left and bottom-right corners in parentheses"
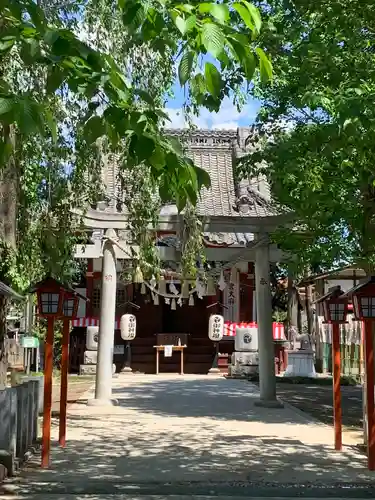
top-left (70, 128), bottom-right (288, 373)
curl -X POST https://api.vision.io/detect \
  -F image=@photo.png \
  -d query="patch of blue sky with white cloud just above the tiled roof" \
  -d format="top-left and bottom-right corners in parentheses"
top-left (166, 83), bottom-right (260, 130)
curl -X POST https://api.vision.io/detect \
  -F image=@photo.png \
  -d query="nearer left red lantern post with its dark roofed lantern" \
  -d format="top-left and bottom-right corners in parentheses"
top-left (31, 278), bottom-right (65, 467)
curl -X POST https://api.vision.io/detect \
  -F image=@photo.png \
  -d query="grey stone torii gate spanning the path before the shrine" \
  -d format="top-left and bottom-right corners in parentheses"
top-left (77, 210), bottom-right (287, 407)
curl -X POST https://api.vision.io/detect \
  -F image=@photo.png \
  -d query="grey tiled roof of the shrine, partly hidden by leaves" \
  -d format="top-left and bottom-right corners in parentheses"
top-left (103, 128), bottom-right (277, 246)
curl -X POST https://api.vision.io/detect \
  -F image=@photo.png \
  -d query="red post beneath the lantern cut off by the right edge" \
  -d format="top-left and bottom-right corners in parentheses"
top-left (364, 319), bottom-right (375, 470)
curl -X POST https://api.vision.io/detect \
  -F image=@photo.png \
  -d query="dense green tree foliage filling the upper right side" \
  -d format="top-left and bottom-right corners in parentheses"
top-left (240, 0), bottom-right (375, 271)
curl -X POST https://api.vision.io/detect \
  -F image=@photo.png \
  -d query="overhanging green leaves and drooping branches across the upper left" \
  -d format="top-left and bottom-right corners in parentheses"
top-left (0, 0), bottom-right (272, 289)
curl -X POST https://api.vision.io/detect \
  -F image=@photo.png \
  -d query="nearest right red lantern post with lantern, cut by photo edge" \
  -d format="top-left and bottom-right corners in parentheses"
top-left (348, 276), bottom-right (375, 470)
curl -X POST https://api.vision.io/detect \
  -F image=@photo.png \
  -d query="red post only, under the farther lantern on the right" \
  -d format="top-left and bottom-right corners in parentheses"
top-left (332, 323), bottom-right (342, 450)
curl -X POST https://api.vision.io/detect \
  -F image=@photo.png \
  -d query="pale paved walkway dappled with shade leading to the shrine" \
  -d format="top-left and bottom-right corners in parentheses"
top-left (2, 375), bottom-right (375, 500)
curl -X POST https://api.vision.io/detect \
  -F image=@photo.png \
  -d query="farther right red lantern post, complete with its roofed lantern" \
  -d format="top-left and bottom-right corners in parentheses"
top-left (317, 286), bottom-right (348, 450)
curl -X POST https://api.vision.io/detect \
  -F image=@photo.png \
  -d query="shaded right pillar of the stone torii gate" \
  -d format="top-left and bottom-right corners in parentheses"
top-left (255, 238), bottom-right (283, 408)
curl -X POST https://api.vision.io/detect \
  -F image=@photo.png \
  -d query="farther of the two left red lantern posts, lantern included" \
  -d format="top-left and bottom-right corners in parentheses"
top-left (59, 291), bottom-right (79, 447)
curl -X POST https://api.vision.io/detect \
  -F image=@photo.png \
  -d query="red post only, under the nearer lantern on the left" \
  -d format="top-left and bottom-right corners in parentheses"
top-left (42, 317), bottom-right (55, 468)
